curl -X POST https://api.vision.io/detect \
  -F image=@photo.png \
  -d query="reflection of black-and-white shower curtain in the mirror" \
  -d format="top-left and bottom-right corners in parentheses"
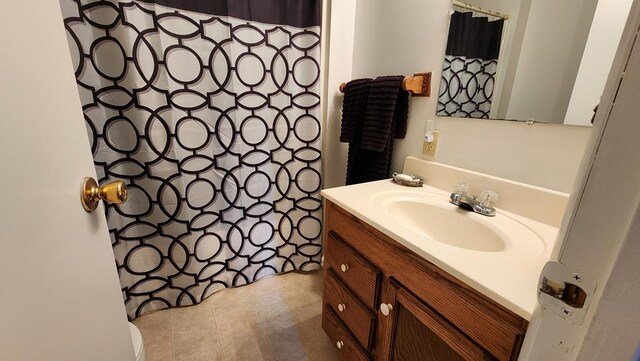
top-left (437, 11), bottom-right (504, 118)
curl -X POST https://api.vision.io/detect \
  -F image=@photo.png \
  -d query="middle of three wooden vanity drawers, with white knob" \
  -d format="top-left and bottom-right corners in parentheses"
top-left (323, 269), bottom-right (375, 350)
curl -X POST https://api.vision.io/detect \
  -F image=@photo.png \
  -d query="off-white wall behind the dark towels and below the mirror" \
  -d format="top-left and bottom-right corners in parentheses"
top-left (325, 0), bottom-right (591, 192)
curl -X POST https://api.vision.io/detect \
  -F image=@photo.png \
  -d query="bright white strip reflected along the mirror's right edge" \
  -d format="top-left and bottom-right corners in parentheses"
top-left (564, 0), bottom-right (633, 125)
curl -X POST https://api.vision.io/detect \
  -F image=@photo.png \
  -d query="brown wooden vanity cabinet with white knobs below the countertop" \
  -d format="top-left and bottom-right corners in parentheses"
top-left (322, 201), bottom-right (528, 361)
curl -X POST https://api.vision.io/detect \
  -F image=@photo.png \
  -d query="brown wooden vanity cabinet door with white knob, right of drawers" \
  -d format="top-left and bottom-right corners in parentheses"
top-left (376, 281), bottom-right (495, 361)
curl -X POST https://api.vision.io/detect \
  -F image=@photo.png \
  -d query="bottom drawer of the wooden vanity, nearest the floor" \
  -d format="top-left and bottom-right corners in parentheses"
top-left (322, 305), bottom-right (371, 361)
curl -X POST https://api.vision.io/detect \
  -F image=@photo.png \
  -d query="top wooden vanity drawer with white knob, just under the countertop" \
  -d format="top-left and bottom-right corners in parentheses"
top-left (326, 231), bottom-right (380, 309)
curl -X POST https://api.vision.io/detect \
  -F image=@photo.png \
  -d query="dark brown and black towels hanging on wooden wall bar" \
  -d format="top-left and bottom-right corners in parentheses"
top-left (340, 76), bottom-right (409, 184)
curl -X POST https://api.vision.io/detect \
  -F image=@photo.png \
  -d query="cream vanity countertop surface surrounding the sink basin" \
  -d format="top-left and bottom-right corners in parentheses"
top-left (322, 180), bottom-right (558, 320)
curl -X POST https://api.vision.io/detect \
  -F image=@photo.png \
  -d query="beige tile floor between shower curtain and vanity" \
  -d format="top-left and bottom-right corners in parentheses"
top-left (133, 272), bottom-right (341, 361)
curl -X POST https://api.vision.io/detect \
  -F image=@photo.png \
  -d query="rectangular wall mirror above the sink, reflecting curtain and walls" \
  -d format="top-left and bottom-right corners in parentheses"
top-left (436, 0), bottom-right (632, 125)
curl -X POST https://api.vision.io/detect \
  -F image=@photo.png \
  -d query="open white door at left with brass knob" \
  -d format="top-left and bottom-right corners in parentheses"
top-left (0, 1), bottom-right (134, 361)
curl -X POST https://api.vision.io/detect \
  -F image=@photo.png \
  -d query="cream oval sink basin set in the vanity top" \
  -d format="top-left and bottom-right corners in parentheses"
top-left (372, 191), bottom-right (545, 257)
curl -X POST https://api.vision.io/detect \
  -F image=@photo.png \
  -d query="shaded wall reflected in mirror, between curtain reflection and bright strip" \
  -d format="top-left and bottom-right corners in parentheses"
top-left (506, 0), bottom-right (600, 123)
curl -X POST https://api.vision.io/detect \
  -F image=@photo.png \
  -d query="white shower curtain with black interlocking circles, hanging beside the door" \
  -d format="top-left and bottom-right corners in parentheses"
top-left (61, 0), bottom-right (321, 319)
